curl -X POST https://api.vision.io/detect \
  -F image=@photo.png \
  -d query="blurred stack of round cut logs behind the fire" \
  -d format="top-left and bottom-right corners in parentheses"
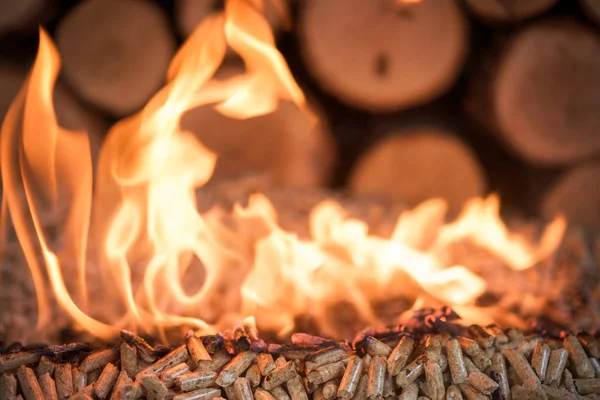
top-left (0, 0), bottom-right (600, 229)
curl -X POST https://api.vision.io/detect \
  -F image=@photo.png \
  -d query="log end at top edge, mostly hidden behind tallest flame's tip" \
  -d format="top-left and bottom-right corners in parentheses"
top-left (175, 0), bottom-right (290, 38)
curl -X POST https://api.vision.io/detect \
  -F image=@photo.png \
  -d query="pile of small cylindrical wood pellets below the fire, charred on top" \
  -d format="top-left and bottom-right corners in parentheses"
top-left (0, 309), bottom-right (600, 400)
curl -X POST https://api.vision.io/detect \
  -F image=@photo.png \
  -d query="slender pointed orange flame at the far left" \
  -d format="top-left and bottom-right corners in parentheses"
top-left (1, 30), bottom-right (110, 337)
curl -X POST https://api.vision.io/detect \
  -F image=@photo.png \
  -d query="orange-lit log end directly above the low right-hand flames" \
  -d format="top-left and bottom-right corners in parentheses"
top-left (349, 127), bottom-right (486, 213)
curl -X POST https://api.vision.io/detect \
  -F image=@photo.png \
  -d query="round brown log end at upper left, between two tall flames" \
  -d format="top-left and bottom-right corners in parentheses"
top-left (56, 0), bottom-right (175, 116)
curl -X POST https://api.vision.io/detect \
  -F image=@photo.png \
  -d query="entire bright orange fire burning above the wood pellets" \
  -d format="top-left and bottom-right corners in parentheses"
top-left (0, 0), bottom-right (565, 338)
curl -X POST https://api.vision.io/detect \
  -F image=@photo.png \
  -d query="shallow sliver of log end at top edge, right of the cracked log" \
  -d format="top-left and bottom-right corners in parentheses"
top-left (465, 0), bottom-right (558, 23)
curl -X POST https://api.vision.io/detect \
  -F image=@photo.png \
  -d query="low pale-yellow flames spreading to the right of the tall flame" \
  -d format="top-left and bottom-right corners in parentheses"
top-left (242, 196), bottom-right (566, 335)
